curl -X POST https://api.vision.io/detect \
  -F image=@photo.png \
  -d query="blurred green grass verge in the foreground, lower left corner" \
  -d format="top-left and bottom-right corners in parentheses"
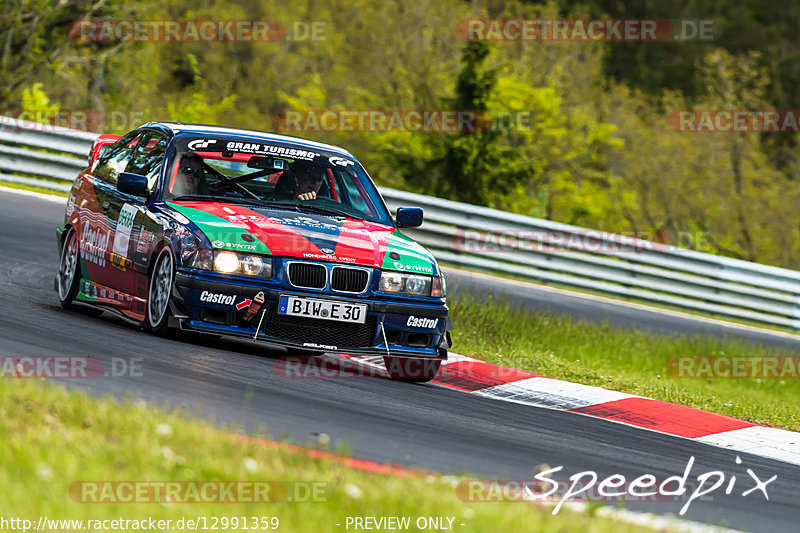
top-left (0, 379), bottom-right (668, 533)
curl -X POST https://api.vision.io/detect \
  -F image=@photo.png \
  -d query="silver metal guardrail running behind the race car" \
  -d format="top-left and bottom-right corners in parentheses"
top-left (0, 117), bottom-right (800, 330)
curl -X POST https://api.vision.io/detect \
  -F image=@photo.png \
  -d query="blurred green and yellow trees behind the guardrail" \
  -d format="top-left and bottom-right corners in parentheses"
top-left (6, 0), bottom-right (800, 268)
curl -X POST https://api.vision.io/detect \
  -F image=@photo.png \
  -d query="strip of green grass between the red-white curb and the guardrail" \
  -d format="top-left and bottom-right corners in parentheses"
top-left (448, 294), bottom-right (800, 431)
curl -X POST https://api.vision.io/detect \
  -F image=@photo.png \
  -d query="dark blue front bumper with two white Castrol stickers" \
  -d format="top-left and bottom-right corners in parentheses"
top-left (173, 271), bottom-right (452, 359)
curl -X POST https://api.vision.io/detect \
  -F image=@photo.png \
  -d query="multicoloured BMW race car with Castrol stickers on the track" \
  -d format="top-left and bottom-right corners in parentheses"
top-left (55, 122), bottom-right (452, 382)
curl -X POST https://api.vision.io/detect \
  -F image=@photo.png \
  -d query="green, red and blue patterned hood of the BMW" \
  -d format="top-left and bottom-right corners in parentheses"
top-left (167, 201), bottom-right (438, 275)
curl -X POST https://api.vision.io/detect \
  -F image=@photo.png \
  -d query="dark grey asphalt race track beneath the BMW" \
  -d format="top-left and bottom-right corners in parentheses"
top-left (0, 191), bottom-right (800, 531)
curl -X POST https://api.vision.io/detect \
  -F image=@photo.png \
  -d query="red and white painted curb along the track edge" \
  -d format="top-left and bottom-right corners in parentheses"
top-left (354, 353), bottom-right (800, 465)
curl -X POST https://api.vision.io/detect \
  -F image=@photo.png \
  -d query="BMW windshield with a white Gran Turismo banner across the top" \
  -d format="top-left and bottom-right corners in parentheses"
top-left (163, 137), bottom-right (391, 225)
